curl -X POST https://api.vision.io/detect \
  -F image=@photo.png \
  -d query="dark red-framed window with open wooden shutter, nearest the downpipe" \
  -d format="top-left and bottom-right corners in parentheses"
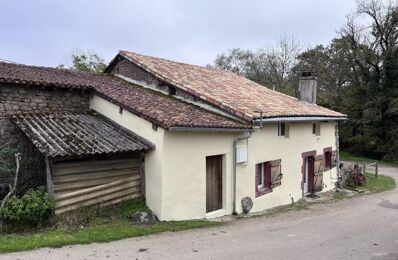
top-left (255, 160), bottom-right (282, 197)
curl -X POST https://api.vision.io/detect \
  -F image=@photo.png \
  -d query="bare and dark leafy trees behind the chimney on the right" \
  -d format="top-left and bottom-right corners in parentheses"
top-left (211, 0), bottom-right (398, 161)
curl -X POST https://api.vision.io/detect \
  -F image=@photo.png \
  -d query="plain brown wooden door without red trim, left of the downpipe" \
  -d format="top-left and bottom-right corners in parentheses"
top-left (206, 155), bottom-right (222, 212)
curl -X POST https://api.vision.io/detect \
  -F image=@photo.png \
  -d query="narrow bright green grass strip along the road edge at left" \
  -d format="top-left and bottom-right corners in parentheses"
top-left (0, 220), bottom-right (218, 253)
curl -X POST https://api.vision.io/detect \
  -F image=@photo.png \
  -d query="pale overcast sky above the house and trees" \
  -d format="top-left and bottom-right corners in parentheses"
top-left (0, 0), bottom-right (355, 66)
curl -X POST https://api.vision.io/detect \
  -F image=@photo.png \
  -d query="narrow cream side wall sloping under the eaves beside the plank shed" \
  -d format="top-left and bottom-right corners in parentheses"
top-left (90, 95), bottom-right (165, 219)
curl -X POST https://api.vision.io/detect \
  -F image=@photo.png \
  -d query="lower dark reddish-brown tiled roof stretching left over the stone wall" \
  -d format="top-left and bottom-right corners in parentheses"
top-left (0, 62), bottom-right (250, 129)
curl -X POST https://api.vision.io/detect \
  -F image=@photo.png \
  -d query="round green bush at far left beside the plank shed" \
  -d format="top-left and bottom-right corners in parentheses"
top-left (0, 187), bottom-right (54, 228)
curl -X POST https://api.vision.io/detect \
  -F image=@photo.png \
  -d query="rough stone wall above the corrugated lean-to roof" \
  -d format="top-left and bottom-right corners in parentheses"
top-left (0, 83), bottom-right (90, 145)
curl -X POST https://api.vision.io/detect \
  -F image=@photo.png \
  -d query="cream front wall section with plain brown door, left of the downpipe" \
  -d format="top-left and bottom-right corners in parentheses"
top-left (162, 131), bottom-right (239, 220)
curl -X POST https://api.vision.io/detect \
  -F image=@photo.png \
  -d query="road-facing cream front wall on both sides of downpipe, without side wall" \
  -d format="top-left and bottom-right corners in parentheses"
top-left (162, 123), bottom-right (337, 220)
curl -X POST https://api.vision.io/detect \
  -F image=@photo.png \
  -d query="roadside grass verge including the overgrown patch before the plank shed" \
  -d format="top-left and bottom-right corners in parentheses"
top-left (0, 200), bottom-right (219, 253)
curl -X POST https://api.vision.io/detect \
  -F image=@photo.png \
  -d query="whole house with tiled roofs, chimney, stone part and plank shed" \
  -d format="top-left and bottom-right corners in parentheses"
top-left (0, 51), bottom-right (346, 220)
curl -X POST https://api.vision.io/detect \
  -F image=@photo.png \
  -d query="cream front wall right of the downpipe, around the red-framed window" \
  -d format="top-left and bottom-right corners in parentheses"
top-left (237, 122), bottom-right (337, 212)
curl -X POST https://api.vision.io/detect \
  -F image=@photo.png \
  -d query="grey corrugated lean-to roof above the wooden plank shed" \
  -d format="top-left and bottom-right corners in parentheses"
top-left (13, 112), bottom-right (153, 158)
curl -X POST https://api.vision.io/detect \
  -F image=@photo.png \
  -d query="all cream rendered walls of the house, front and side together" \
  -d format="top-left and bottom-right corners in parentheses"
top-left (90, 95), bottom-right (337, 220)
